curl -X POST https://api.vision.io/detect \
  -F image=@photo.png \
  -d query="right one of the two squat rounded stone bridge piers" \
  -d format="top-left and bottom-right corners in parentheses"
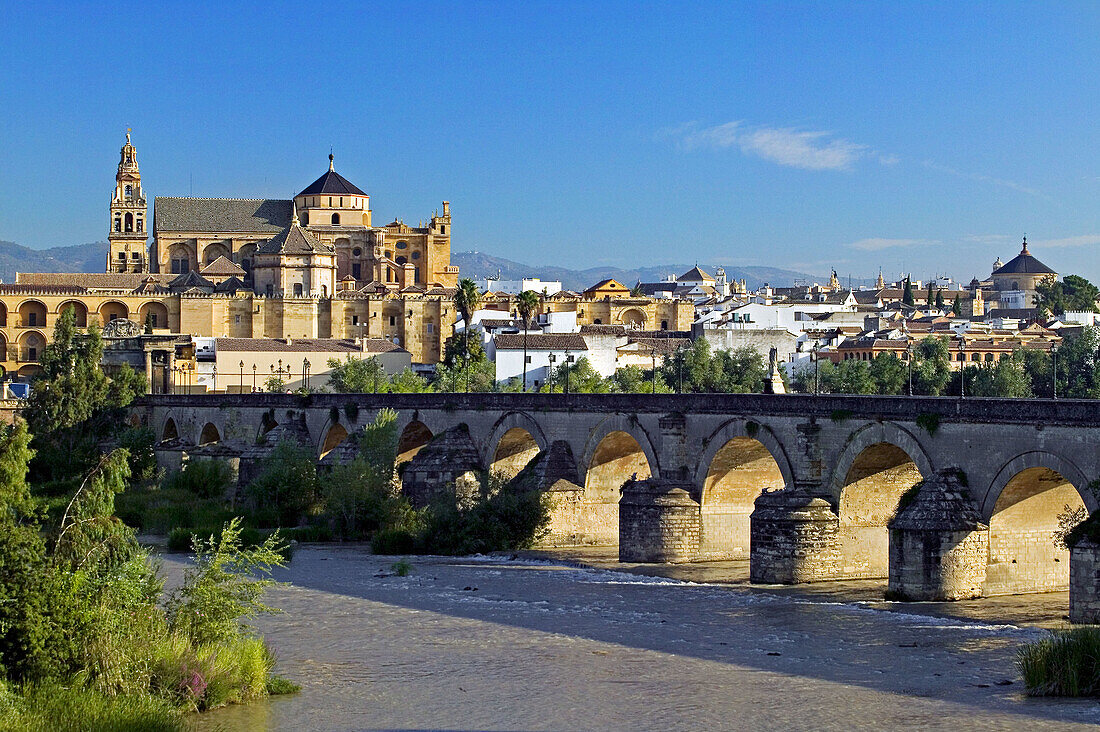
top-left (749, 488), bottom-right (840, 584)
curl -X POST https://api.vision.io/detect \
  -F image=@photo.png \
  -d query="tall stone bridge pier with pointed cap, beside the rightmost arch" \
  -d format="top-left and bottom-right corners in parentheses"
top-left (887, 469), bottom-right (989, 601)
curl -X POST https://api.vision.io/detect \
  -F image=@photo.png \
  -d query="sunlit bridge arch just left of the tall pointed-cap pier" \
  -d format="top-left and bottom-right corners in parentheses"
top-left (828, 422), bottom-right (934, 578)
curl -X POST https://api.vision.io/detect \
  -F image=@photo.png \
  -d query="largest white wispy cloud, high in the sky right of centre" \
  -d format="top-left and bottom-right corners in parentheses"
top-left (664, 121), bottom-right (880, 171)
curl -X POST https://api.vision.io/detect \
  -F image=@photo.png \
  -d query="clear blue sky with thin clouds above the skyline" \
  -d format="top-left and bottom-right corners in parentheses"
top-left (0, 2), bottom-right (1100, 281)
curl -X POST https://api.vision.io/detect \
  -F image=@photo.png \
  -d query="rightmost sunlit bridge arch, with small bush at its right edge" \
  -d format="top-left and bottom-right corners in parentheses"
top-left (981, 450), bottom-right (1097, 596)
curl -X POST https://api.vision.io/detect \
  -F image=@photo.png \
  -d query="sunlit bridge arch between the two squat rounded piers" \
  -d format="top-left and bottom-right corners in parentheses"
top-left (692, 419), bottom-right (793, 559)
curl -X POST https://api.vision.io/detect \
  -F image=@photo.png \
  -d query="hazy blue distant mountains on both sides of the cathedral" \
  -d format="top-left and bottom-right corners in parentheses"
top-left (0, 240), bottom-right (871, 292)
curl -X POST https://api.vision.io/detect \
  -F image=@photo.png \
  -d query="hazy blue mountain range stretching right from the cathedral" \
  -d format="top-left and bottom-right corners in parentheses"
top-left (451, 252), bottom-right (873, 292)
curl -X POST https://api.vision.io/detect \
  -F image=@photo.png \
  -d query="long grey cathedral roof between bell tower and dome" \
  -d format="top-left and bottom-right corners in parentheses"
top-left (153, 196), bottom-right (292, 233)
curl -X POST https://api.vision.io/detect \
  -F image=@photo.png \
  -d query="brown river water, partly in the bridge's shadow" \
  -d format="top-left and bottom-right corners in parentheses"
top-left (173, 546), bottom-right (1100, 732)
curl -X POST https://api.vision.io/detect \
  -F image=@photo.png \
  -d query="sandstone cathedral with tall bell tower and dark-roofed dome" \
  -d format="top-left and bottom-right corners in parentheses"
top-left (107, 132), bottom-right (459, 290)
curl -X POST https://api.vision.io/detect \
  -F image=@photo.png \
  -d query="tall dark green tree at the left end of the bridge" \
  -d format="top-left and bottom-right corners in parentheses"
top-left (23, 307), bottom-right (147, 480)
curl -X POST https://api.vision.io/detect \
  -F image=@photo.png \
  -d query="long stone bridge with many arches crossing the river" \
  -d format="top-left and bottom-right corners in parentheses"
top-left (134, 394), bottom-right (1100, 612)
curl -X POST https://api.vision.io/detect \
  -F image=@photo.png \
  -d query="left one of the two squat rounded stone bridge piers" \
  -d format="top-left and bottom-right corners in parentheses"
top-left (619, 479), bottom-right (703, 562)
